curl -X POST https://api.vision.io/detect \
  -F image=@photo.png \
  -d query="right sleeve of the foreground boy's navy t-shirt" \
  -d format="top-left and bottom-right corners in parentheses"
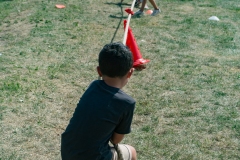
top-left (114, 103), bottom-right (135, 134)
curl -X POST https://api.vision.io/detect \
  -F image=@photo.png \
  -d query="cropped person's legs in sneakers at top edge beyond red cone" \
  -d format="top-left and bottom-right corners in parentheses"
top-left (133, 0), bottom-right (161, 16)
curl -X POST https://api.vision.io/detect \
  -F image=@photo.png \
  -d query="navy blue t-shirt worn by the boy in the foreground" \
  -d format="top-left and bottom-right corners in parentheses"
top-left (61, 80), bottom-right (135, 160)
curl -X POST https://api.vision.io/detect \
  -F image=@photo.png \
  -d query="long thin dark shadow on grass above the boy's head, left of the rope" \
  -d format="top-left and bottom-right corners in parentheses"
top-left (105, 2), bottom-right (129, 43)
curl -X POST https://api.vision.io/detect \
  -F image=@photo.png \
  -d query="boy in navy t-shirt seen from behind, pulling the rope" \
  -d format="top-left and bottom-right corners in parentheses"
top-left (61, 43), bottom-right (137, 160)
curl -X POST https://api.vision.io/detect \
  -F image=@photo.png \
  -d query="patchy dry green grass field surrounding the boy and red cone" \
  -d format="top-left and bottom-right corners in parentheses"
top-left (0, 0), bottom-right (240, 160)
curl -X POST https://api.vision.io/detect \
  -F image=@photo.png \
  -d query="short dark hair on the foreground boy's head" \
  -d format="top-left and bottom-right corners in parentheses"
top-left (98, 42), bottom-right (133, 77)
